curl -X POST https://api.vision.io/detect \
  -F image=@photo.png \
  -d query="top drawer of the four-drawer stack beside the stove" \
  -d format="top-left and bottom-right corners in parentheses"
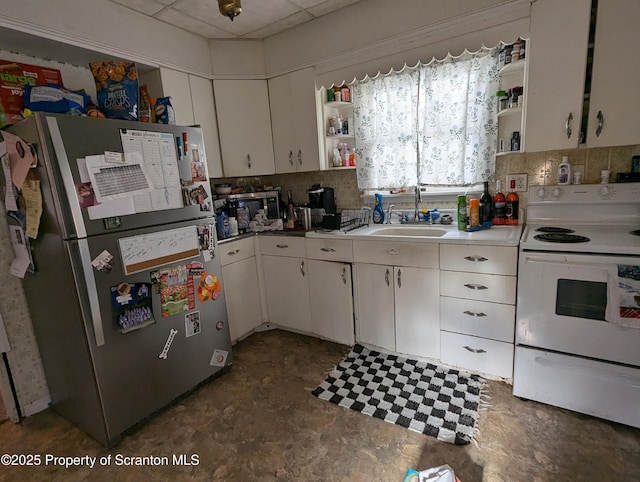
top-left (440, 244), bottom-right (518, 276)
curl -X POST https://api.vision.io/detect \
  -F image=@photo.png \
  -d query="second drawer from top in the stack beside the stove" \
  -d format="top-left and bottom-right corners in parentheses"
top-left (440, 271), bottom-right (517, 304)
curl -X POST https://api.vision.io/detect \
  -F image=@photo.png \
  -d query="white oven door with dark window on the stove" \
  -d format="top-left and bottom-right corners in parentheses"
top-left (516, 251), bottom-right (640, 366)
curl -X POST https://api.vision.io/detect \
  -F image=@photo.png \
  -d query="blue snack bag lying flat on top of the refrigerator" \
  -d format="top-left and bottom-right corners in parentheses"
top-left (24, 84), bottom-right (91, 115)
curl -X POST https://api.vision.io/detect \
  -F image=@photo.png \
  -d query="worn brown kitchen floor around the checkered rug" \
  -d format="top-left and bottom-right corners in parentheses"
top-left (0, 330), bottom-right (640, 482)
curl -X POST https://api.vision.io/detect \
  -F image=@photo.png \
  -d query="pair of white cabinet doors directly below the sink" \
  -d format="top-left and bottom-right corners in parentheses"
top-left (356, 263), bottom-right (440, 359)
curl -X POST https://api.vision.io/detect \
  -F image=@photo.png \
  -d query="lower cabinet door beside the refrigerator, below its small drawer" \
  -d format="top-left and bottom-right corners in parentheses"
top-left (222, 257), bottom-right (262, 341)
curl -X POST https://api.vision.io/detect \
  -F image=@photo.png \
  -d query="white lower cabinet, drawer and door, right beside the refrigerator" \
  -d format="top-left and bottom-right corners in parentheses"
top-left (219, 238), bottom-right (262, 342)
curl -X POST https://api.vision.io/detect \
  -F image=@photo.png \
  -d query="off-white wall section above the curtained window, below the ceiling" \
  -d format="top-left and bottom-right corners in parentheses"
top-left (265, 0), bottom-right (530, 85)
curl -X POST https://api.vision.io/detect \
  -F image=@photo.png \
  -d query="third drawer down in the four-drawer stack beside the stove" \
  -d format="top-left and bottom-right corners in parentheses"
top-left (440, 296), bottom-right (516, 343)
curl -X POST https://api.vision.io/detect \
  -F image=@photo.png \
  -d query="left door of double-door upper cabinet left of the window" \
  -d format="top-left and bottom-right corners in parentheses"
top-left (269, 74), bottom-right (298, 174)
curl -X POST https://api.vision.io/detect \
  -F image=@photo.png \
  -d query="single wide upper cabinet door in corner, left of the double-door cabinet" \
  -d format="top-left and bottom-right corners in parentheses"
top-left (213, 80), bottom-right (275, 177)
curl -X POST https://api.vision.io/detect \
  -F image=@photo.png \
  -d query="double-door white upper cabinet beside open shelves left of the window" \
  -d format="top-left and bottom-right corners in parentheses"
top-left (269, 68), bottom-right (320, 173)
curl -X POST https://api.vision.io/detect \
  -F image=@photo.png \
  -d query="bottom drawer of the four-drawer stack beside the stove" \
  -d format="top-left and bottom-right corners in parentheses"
top-left (440, 331), bottom-right (513, 378)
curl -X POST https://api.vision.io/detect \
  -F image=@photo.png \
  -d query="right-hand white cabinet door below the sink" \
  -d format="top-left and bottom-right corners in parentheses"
top-left (393, 267), bottom-right (440, 359)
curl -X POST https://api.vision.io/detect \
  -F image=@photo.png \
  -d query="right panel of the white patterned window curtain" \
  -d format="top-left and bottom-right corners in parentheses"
top-left (418, 52), bottom-right (500, 186)
